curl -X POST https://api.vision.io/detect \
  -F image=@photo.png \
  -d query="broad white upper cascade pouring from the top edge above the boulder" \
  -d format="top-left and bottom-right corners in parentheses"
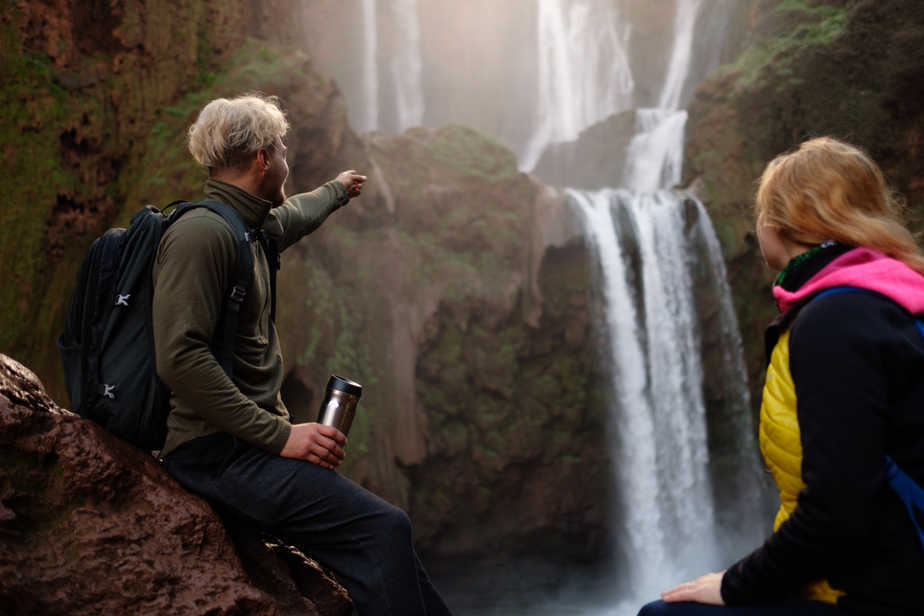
top-left (519, 0), bottom-right (634, 169)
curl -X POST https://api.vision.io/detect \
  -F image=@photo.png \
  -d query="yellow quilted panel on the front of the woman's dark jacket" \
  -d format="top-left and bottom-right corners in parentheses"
top-left (760, 331), bottom-right (844, 603)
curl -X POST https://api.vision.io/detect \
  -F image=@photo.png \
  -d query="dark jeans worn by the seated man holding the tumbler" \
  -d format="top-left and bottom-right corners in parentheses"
top-left (164, 434), bottom-right (450, 616)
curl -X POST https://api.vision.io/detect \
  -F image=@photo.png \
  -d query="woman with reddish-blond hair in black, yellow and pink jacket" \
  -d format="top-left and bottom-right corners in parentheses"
top-left (640, 138), bottom-right (924, 616)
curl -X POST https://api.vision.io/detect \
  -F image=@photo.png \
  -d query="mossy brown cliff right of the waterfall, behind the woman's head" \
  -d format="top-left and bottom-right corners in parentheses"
top-left (684, 0), bottom-right (924, 414)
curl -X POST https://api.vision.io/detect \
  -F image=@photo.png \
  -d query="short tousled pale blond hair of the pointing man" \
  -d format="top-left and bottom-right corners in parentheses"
top-left (187, 93), bottom-right (289, 169)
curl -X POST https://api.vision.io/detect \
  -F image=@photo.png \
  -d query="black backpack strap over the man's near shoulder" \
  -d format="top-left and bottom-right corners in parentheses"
top-left (168, 201), bottom-right (254, 379)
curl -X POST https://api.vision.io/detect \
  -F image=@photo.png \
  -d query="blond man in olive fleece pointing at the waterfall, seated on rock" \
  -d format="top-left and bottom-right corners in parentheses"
top-left (153, 96), bottom-right (449, 616)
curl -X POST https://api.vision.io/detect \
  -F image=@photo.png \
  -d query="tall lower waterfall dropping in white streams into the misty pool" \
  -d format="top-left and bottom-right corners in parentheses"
top-left (568, 189), bottom-right (727, 597)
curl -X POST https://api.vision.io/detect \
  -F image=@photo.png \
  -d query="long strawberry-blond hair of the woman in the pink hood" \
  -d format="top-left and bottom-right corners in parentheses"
top-left (754, 137), bottom-right (924, 274)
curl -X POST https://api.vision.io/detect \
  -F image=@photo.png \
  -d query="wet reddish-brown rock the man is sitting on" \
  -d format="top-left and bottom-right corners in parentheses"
top-left (0, 355), bottom-right (352, 616)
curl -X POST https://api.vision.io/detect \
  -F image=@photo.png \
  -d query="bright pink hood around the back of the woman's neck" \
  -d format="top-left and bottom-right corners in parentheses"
top-left (773, 248), bottom-right (924, 314)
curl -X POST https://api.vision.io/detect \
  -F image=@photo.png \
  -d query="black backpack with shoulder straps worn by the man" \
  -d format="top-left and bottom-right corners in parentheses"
top-left (58, 201), bottom-right (279, 450)
